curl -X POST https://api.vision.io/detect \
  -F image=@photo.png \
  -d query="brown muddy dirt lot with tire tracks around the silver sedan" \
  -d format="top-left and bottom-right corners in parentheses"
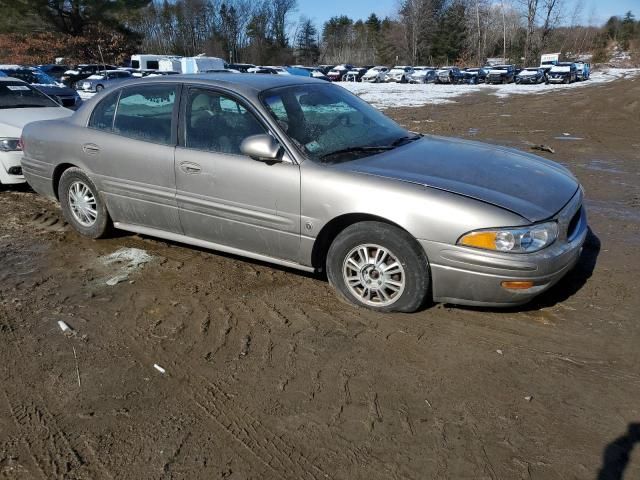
top-left (0, 79), bottom-right (640, 480)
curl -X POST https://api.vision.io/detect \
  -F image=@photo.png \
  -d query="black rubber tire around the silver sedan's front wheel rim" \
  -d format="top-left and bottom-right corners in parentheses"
top-left (327, 221), bottom-right (430, 313)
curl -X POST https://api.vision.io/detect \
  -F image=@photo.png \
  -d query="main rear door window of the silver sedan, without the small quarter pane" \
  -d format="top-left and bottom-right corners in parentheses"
top-left (113, 85), bottom-right (177, 145)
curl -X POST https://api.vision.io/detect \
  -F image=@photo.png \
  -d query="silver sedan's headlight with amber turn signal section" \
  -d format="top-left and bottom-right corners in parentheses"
top-left (458, 222), bottom-right (558, 253)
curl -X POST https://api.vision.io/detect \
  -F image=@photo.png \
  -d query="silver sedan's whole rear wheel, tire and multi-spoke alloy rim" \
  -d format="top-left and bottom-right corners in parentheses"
top-left (58, 168), bottom-right (111, 238)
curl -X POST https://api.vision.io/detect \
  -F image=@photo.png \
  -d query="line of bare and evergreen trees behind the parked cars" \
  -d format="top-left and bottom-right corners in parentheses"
top-left (0, 0), bottom-right (640, 65)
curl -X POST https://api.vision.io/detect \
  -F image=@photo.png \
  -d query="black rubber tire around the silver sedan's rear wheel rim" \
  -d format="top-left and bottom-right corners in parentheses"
top-left (58, 167), bottom-right (113, 238)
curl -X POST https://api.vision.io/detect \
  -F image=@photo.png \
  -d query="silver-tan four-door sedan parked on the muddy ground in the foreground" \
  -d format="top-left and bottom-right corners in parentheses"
top-left (22, 73), bottom-right (587, 312)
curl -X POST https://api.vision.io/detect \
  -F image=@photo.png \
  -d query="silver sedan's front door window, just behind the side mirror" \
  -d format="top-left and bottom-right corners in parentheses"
top-left (184, 89), bottom-right (266, 155)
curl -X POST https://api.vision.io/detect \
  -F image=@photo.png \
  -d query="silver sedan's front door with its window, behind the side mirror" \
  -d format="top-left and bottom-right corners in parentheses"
top-left (175, 88), bottom-right (300, 261)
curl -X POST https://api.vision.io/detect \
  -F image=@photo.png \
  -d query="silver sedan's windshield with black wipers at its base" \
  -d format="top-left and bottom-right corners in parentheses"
top-left (261, 85), bottom-right (418, 162)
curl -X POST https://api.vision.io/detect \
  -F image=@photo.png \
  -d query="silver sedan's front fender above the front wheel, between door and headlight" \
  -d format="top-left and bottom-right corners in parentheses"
top-left (301, 161), bottom-right (527, 265)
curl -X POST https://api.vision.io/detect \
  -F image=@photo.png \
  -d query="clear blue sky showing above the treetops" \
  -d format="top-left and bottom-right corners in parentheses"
top-left (296, 0), bottom-right (640, 26)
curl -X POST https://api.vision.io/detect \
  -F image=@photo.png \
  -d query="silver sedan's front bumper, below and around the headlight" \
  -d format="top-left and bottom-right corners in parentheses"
top-left (420, 191), bottom-right (588, 307)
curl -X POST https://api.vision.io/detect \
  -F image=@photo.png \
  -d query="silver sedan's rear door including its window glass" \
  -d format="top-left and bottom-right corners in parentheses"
top-left (82, 83), bottom-right (182, 233)
